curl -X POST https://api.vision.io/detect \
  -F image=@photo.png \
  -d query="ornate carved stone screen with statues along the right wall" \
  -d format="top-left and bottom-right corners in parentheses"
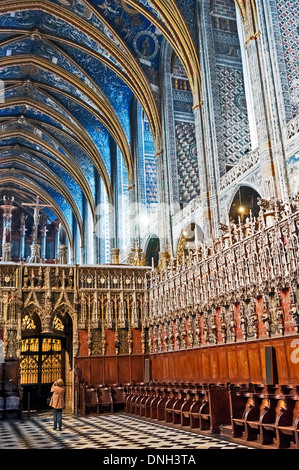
top-left (145, 197), bottom-right (299, 352)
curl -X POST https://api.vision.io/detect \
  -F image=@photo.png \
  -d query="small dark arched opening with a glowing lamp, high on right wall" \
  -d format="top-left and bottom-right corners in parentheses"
top-left (229, 186), bottom-right (260, 224)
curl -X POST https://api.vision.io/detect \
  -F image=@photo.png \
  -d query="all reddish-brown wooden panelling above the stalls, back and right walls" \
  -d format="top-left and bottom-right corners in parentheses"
top-left (77, 336), bottom-right (299, 385)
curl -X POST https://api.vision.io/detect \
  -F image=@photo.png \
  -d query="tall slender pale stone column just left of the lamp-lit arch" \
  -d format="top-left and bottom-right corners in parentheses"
top-left (193, 2), bottom-right (224, 243)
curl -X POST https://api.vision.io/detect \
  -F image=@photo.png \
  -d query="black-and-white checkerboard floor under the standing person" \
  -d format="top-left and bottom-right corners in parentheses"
top-left (0, 413), bottom-right (253, 449)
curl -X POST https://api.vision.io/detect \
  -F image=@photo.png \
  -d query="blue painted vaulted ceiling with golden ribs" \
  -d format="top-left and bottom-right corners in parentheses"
top-left (0, 0), bottom-right (204, 250)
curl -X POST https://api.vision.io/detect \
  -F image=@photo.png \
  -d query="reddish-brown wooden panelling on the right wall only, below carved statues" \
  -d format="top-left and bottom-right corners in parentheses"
top-left (151, 337), bottom-right (299, 384)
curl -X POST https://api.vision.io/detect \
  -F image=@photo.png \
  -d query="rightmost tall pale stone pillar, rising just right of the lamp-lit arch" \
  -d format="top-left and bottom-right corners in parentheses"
top-left (243, 0), bottom-right (289, 202)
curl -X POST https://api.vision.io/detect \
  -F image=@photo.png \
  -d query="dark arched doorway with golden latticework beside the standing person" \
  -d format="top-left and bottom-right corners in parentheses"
top-left (20, 310), bottom-right (72, 411)
